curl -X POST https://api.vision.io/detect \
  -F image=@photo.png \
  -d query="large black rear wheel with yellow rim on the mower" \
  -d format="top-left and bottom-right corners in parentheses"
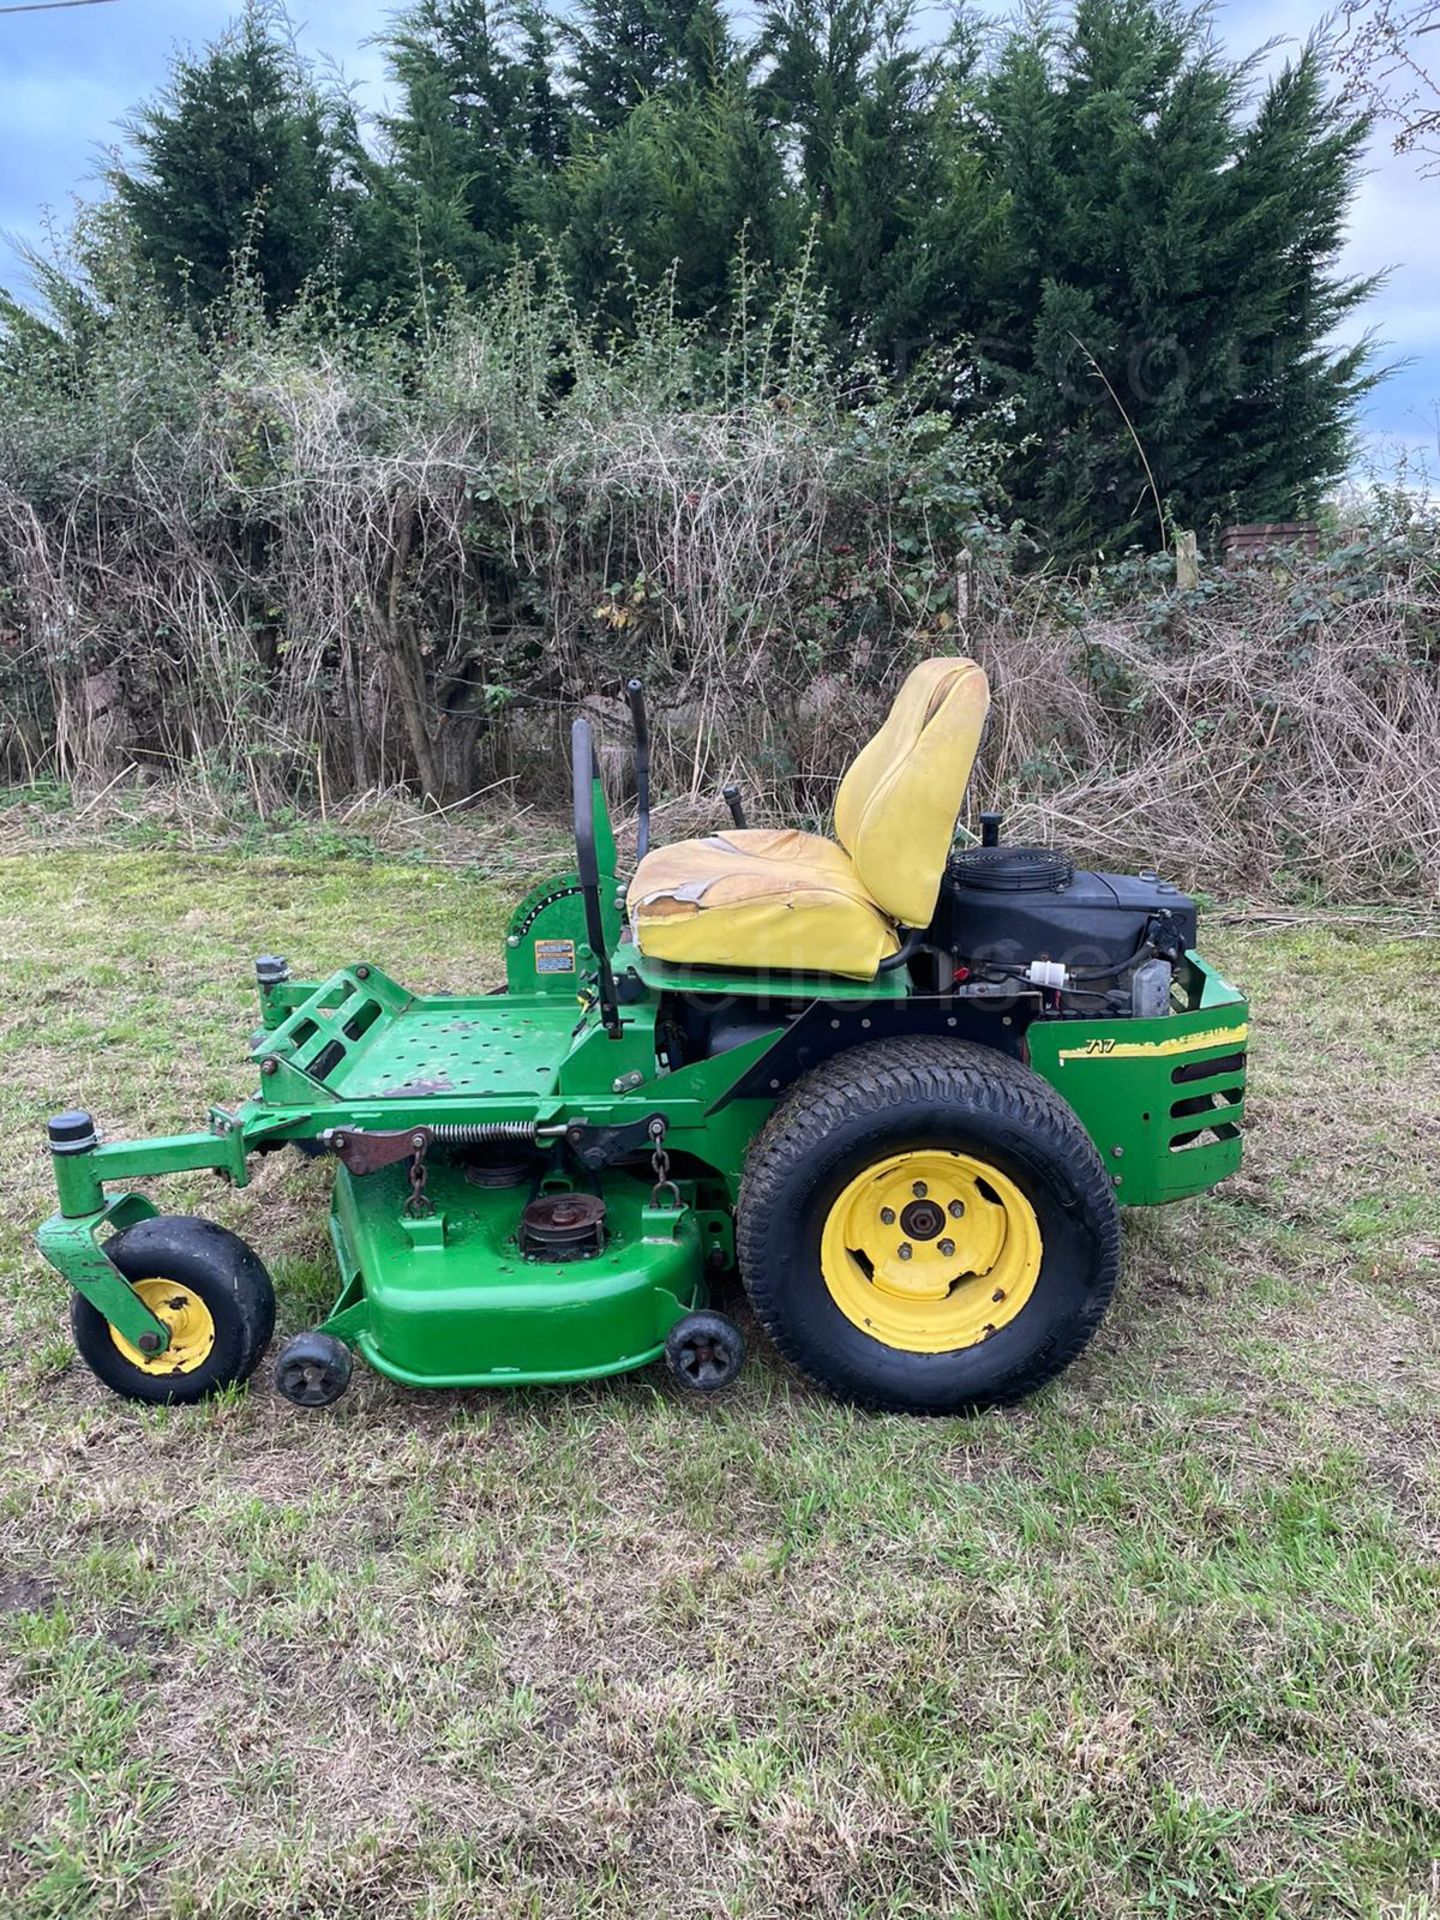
top-left (737, 1039), bottom-right (1119, 1413)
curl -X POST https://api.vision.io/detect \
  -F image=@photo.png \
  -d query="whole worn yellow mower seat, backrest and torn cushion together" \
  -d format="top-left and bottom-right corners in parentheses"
top-left (626, 660), bottom-right (989, 979)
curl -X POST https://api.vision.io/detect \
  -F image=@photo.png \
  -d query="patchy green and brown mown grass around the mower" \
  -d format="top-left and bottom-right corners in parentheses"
top-left (0, 851), bottom-right (1440, 1920)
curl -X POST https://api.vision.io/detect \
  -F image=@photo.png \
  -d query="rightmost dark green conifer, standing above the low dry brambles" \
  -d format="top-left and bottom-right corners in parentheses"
top-left (973, 0), bottom-right (1373, 553)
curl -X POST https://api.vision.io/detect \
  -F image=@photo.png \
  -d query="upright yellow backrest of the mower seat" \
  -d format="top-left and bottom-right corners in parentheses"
top-left (835, 660), bottom-right (991, 927)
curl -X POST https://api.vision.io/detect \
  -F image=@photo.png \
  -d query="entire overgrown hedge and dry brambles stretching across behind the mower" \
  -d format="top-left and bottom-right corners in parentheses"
top-left (0, 253), bottom-right (1440, 897)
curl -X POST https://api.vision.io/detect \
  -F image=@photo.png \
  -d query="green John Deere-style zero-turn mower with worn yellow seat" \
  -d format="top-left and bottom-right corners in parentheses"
top-left (38, 659), bottom-right (1246, 1413)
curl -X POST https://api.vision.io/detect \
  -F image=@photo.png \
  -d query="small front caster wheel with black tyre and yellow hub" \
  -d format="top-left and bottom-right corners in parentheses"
top-left (69, 1213), bottom-right (275, 1405)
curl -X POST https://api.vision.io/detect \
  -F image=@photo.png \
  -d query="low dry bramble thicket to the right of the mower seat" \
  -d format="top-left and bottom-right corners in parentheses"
top-left (979, 541), bottom-right (1440, 900)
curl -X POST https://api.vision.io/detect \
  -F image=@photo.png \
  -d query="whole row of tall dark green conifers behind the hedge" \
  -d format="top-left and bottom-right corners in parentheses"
top-left (96, 0), bottom-right (1377, 557)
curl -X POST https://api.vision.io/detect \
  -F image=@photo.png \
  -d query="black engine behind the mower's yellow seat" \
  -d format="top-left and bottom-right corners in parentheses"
top-left (933, 847), bottom-right (1196, 972)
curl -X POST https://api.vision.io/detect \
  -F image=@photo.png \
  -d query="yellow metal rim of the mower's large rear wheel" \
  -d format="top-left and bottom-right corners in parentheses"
top-left (820, 1150), bottom-right (1043, 1354)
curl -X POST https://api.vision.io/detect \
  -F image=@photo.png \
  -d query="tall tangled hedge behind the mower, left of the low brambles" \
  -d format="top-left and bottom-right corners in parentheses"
top-left (0, 255), bottom-right (998, 806)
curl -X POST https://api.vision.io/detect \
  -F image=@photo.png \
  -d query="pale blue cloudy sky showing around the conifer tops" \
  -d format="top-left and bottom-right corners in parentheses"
top-left (0, 0), bottom-right (1440, 467)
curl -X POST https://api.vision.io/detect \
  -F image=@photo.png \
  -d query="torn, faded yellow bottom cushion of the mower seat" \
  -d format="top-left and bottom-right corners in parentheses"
top-left (626, 828), bottom-right (899, 979)
